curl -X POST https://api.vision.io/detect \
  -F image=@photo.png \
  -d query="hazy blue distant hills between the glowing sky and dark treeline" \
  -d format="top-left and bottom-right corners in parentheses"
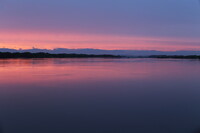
top-left (0, 48), bottom-right (200, 56)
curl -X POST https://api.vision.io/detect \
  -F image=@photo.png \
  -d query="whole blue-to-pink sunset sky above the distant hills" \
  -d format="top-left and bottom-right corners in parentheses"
top-left (0, 0), bottom-right (200, 51)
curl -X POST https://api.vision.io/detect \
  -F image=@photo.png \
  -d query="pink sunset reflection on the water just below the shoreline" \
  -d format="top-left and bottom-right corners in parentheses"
top-left (0, 59), bottom-right (199, 85)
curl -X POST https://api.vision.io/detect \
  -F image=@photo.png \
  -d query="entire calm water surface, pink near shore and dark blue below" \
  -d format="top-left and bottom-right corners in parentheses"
top-left (0, 59), bottom-right (200, 133)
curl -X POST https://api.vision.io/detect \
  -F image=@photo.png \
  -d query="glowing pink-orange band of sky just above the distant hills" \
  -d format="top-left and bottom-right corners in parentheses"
top-left (0, 32), bottom-right (200, 51)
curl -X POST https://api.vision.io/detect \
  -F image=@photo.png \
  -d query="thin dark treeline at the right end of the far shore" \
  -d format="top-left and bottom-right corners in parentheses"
top-left (149, 55), bottom-right (200, 59)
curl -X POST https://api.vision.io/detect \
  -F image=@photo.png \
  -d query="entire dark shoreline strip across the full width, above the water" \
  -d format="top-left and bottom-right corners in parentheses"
top-left (0, 52), bottom-right (200, 59)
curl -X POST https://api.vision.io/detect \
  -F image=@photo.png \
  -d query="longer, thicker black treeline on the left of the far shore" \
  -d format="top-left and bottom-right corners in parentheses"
top-left (0, 52), bottom-right (121, 58)
